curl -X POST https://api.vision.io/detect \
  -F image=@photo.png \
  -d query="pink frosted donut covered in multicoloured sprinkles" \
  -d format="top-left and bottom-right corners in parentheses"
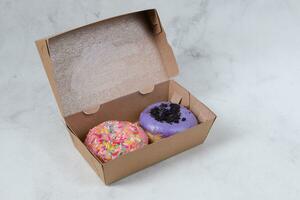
top-left (84, 121), bottom-right (148, 162)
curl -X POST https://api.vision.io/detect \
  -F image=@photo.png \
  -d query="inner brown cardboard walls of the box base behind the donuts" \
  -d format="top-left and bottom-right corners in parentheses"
top-left (65, 81), bottom-right (215, 148)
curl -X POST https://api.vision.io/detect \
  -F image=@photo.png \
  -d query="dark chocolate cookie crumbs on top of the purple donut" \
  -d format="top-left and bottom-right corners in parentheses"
top-left (150, 103), bottom-right (182, 124)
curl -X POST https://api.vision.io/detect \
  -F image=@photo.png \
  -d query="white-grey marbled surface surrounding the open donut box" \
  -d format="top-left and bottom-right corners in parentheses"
top-left (0, 0), bottom-right (300, 200)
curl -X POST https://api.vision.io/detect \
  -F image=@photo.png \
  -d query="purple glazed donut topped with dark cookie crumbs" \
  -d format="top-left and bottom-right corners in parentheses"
top-left (139, 101), bottom-right (198, 139)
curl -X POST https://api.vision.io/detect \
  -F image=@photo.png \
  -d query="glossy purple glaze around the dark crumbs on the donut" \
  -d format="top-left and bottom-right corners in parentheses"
top-left (139, 101), bottom-right (198, 137)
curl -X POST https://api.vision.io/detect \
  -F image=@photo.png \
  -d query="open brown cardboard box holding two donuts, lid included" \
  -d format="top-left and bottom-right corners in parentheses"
top-left (36, 9), bottom-right (216, 184)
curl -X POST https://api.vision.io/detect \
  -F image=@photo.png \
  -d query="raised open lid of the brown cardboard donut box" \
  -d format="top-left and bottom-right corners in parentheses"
top-left (36, 9), bottom-right (178, 117)
